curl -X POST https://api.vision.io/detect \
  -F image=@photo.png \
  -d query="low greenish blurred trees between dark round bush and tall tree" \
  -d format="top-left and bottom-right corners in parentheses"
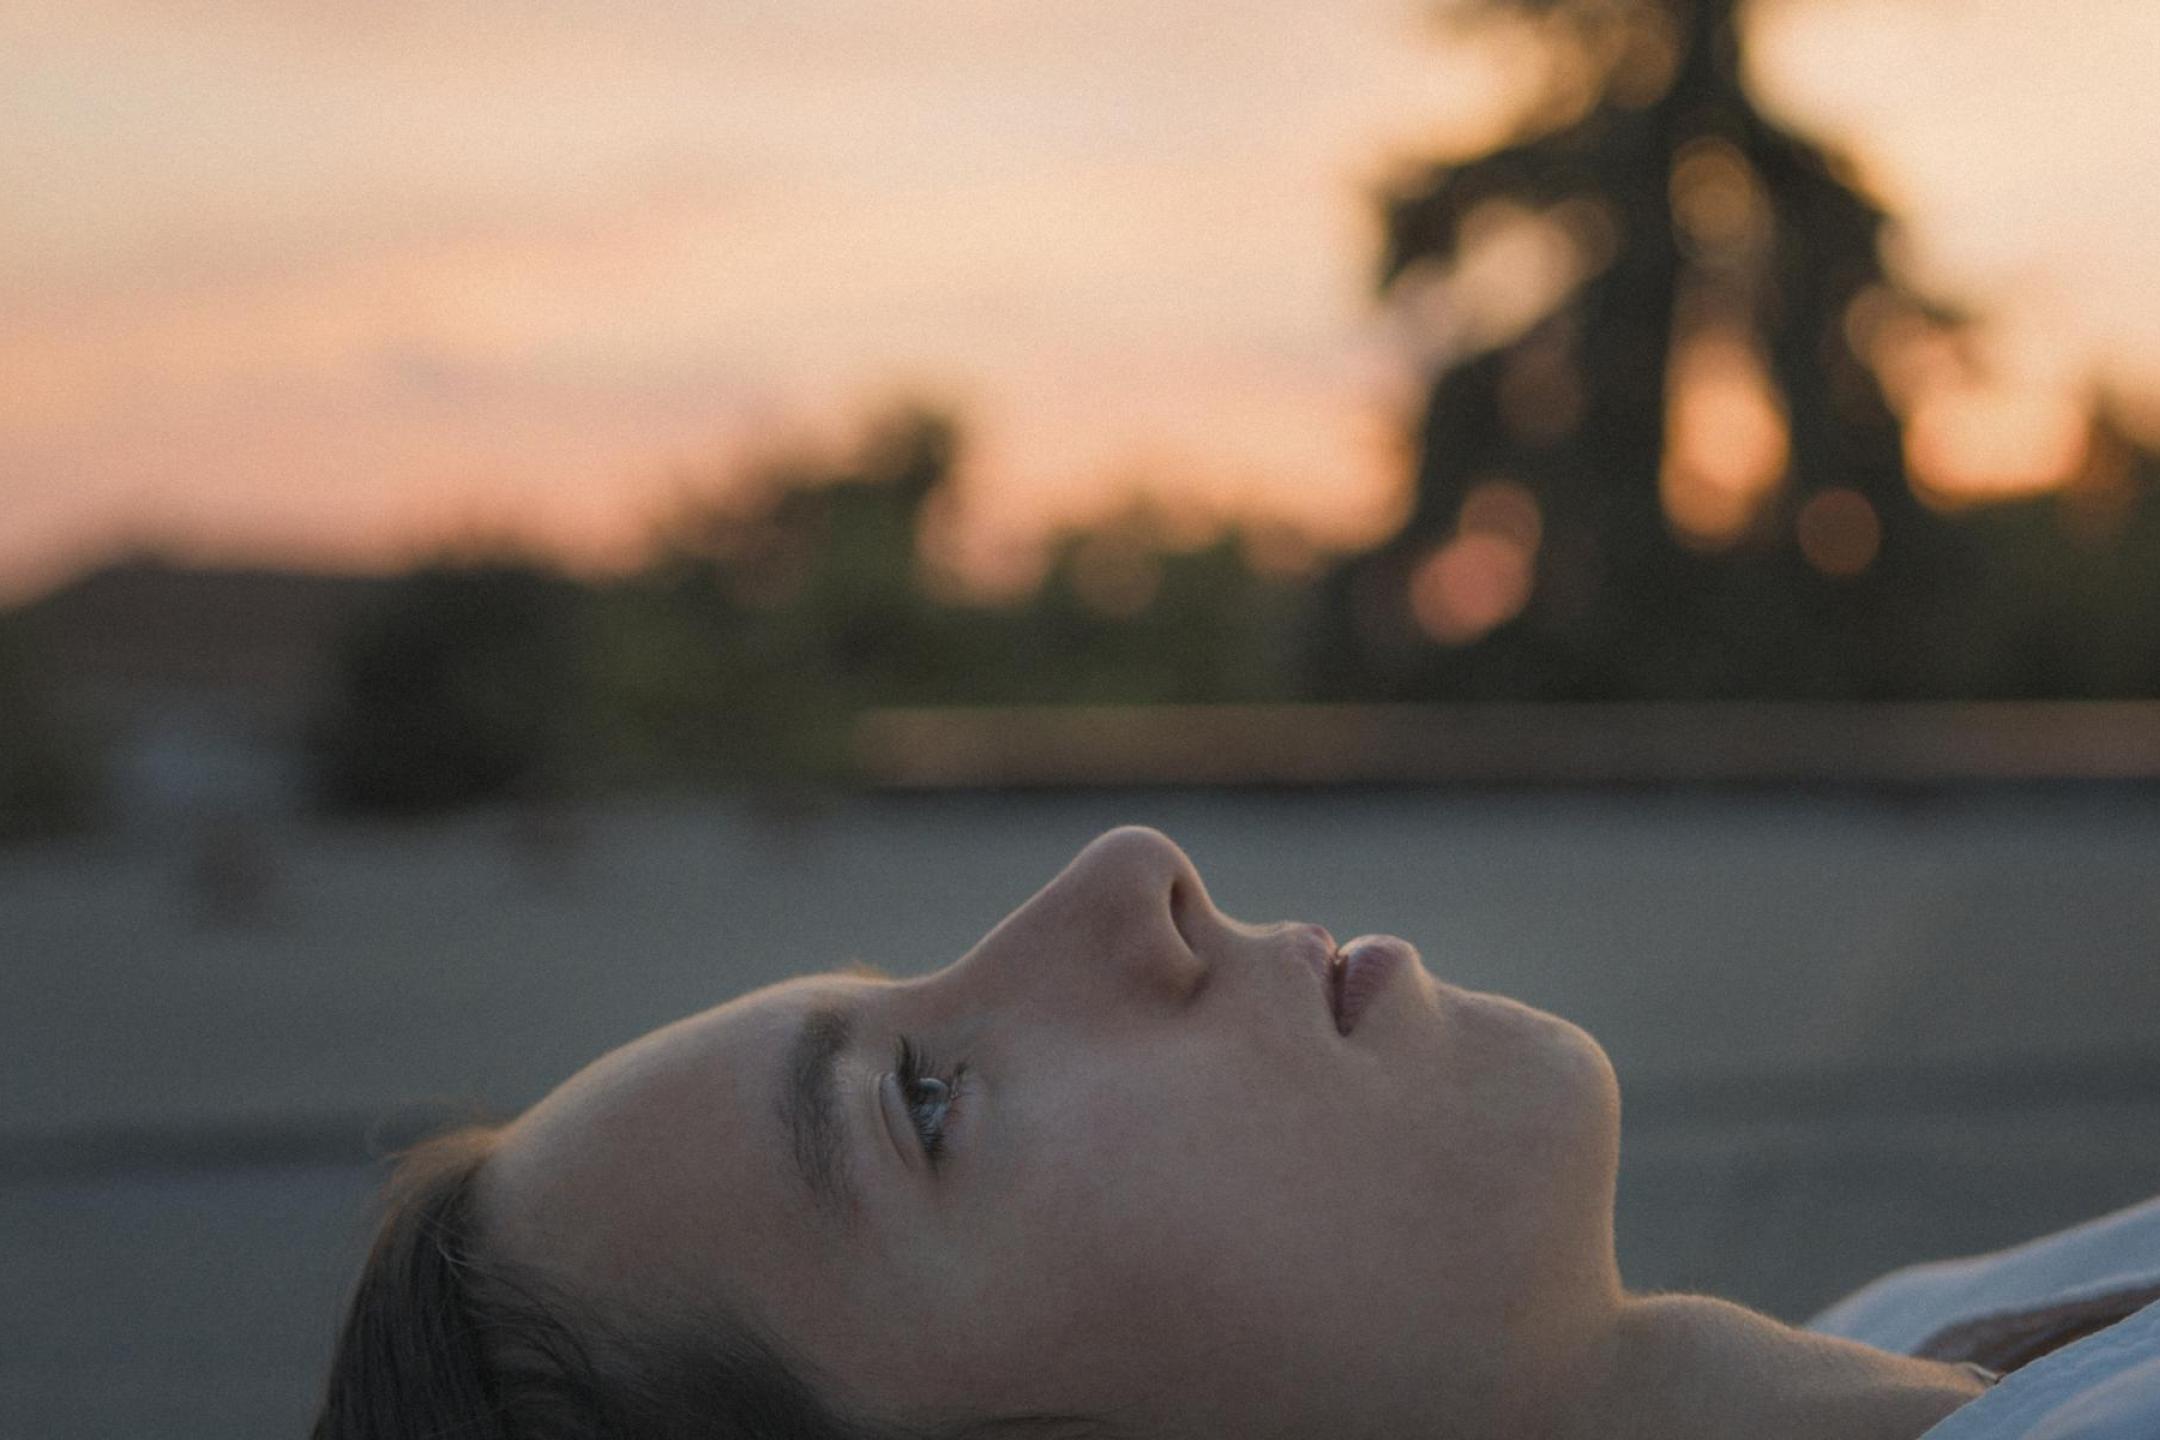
top-left (600, 404), bottom-right (1294, 782)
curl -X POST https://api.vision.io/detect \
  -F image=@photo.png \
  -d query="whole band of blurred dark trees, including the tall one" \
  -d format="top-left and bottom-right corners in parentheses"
top-left (291, 0), bottom-right (2160, 805)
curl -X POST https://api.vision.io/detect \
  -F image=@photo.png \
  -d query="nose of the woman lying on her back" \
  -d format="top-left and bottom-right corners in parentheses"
top-left (961, 825), bottom-right (1220, 1010)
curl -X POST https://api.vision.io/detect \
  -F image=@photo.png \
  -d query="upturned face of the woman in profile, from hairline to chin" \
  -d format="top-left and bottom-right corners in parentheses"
top-left (486, 829), bottom-right (1620, 1436)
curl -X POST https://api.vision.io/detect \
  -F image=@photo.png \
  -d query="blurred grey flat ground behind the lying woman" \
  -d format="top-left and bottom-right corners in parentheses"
top-left (0, 788), bottom-right (2160, 1440)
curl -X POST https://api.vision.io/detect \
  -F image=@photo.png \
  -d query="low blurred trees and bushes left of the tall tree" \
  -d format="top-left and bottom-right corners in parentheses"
top-left (311, 406), bottom-right (1300, 810)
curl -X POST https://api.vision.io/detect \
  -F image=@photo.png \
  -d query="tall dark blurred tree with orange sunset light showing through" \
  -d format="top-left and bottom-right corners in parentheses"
top-left (1313, 0), bottom-right (1981, 697)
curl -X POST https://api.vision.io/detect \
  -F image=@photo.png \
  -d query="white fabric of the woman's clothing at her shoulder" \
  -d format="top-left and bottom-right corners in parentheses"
top-left (1808, 1198), bottom-right (2160, 1440)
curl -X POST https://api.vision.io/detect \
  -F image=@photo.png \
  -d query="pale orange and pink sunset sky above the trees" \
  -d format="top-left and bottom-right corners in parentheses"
top-left (0, 0), bottom-right (2160, 598)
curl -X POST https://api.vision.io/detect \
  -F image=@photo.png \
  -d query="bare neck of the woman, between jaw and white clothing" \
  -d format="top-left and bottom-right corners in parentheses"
top-left (1553, 1295), bottom-right (1985, 1440)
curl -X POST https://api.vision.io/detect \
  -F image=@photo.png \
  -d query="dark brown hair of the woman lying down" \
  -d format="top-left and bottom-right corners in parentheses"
top-left (313, 1125), bottom-right (1102, 1440)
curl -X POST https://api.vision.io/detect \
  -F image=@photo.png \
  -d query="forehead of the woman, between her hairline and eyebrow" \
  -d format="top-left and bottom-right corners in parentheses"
top-left (486, 978), bottom-right (849, 1300)
